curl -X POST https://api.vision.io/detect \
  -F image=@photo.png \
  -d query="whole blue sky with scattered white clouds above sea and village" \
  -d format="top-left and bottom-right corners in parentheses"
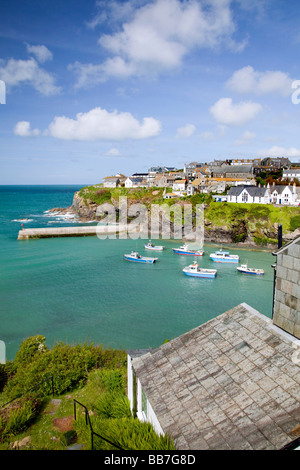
top-left (0, 0), bottom-right (300, 185)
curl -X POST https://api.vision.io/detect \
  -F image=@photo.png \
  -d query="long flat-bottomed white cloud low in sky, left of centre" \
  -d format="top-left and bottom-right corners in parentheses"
top-left (48, 107), bottom-right (161, 141)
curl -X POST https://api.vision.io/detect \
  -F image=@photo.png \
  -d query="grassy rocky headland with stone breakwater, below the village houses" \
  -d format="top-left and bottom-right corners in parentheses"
top-left (18, 185), bottom-right (300, 249)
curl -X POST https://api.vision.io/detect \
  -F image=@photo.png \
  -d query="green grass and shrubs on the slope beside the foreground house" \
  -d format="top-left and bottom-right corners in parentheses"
top-left (0, 335), bottom-right (174, 450)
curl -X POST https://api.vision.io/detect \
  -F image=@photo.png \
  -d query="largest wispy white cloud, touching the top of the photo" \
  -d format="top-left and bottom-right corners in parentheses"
top-left (75, 0), bottom-right (245, 86)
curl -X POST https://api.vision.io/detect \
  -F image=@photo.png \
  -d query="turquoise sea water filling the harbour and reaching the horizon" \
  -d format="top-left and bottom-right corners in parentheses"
top-left (0, 184), bottom-right (275, 360)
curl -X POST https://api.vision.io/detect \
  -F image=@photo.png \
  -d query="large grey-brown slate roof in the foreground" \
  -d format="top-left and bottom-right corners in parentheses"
top-left (132, 304), bottom-right (300, 450)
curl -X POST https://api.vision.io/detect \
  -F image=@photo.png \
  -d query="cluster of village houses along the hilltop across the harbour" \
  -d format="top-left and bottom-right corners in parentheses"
top-left (103, 158), bottom-right (300, 206)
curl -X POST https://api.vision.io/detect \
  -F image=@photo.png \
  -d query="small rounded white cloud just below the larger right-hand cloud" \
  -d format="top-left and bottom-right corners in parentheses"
top-left (210, 98), bottom-right (262, 126)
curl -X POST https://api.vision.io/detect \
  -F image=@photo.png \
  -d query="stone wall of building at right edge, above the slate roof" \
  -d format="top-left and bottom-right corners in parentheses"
top-left (273, 237), bottom-right (300, 339)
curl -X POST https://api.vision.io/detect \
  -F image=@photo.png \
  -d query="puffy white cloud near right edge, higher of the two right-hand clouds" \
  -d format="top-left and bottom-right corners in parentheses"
top-left (226, 65), bottom-right (293, 96)
